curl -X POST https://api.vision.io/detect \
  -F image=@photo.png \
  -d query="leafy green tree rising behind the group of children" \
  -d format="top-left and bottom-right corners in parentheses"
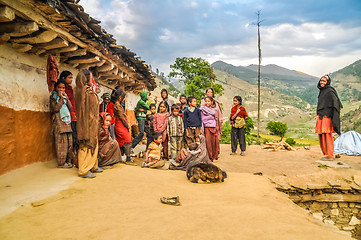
top-left (168, 57), bottom-right (223, 103)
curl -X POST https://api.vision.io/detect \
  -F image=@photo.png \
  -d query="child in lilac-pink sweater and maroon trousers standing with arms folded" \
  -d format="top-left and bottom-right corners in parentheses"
top-left (201, 96), bottom-right (219, 162)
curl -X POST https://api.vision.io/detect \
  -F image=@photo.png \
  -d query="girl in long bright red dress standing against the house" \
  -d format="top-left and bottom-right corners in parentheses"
top-left (113, 89), bottom-right (132, 162)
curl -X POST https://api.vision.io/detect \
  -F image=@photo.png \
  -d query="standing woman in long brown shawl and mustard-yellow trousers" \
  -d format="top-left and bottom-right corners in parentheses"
top-left (75, 69), bottom-right (103, 178)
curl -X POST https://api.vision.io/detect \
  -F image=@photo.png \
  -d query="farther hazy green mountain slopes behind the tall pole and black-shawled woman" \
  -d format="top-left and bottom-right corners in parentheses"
top-left (212, 60), bottom-right (361, 105)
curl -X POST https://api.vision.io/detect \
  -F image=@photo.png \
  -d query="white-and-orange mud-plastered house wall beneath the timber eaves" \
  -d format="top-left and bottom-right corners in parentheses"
top-left (0, 45), bottom-right (77, 174)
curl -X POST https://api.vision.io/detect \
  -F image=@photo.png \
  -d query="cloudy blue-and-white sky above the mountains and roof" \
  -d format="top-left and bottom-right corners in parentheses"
top-left (80, 0), bottom-right (361, 76)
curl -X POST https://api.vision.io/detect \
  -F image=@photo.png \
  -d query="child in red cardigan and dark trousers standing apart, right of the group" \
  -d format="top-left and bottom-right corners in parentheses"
top-left (230, 96), bottom-right (248, 156)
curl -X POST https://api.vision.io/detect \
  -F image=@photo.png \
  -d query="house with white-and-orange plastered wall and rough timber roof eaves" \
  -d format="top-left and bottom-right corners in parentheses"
top-left (0, 0), bottom-right (156, 174)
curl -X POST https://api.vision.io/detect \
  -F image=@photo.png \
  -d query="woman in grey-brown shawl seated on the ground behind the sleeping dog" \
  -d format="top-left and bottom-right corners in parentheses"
top-left (169, 135), bottom-right (210, 171)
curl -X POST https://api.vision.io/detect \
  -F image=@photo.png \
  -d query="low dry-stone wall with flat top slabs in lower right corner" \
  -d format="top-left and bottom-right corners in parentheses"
top-left (271, 175), bottom-right (361, 239)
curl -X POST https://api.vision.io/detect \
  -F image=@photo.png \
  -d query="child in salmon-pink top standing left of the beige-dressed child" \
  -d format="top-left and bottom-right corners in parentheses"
top-left (153, 101), bottom-right (169, 160)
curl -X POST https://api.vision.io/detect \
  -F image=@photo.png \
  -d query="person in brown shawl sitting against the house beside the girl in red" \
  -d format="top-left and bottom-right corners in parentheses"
top-left (98, 112), bottom-right (122, 167)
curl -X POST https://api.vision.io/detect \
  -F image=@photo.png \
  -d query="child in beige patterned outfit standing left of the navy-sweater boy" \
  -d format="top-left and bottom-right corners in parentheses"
top-left (167, 104), bottom-right (184, 159)
